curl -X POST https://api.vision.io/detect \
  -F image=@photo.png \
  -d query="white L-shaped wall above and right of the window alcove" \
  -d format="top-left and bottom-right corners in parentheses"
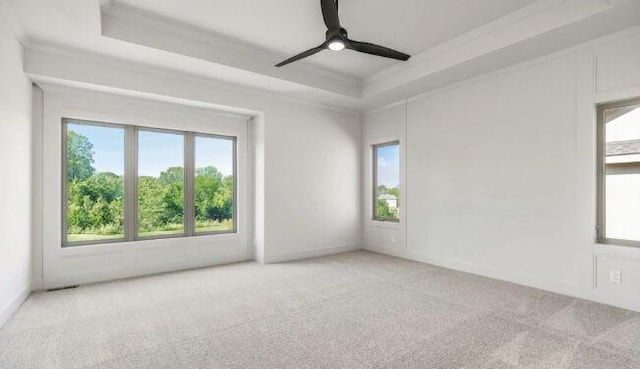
top-left (24, 43), bottom-right (362, 278)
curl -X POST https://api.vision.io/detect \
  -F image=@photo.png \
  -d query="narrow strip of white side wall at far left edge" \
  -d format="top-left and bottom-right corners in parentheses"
top-left (0, 9), bottom-right (31, 326)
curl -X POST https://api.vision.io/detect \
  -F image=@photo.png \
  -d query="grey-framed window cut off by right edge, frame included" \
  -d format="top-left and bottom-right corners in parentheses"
top-left (598, 99), bottom-right (640, 246)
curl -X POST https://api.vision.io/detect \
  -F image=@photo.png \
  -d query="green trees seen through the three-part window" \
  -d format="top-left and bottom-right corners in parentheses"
top-left (67, 130), bottom-right (233, 240)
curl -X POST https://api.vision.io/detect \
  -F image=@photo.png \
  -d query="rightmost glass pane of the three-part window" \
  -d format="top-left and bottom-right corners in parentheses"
top-left (194, 136), bottom-right (235, 233)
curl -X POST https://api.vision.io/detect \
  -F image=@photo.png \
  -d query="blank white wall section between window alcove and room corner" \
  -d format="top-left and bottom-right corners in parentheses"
top-left (265, 100), bottom-right (362, 262)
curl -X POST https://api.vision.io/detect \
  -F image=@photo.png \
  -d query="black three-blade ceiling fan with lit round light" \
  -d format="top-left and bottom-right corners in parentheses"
top-left (276, 0), bottom-right (411, 67)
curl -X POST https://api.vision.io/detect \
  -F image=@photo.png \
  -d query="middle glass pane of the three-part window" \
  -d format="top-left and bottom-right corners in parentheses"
top-left (138, 130), bottom-right (185, 237)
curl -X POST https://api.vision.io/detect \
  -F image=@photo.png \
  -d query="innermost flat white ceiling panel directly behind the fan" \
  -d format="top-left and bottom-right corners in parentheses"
top-left (113, 0), bottom-right (535, 78)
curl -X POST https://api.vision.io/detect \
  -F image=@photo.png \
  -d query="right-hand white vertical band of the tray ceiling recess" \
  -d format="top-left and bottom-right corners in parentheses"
top-left (363, 0), bottom-right (613, 98)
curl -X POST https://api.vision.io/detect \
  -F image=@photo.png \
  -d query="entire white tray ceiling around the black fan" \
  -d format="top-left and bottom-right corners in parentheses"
top-left (7, 0), bottom-right (640, 111)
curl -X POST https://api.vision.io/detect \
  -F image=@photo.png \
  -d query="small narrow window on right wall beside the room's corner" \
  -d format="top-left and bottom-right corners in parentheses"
top-left (374, 143), bottom-right (400, 220)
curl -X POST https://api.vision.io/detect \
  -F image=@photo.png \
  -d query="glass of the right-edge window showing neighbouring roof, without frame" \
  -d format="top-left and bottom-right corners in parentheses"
top-left (605, 105), bottom-right (640, 241)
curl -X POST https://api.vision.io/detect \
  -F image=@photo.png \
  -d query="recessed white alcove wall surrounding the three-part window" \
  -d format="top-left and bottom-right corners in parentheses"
top-left (35, 85), bottom-right (252, 288)
